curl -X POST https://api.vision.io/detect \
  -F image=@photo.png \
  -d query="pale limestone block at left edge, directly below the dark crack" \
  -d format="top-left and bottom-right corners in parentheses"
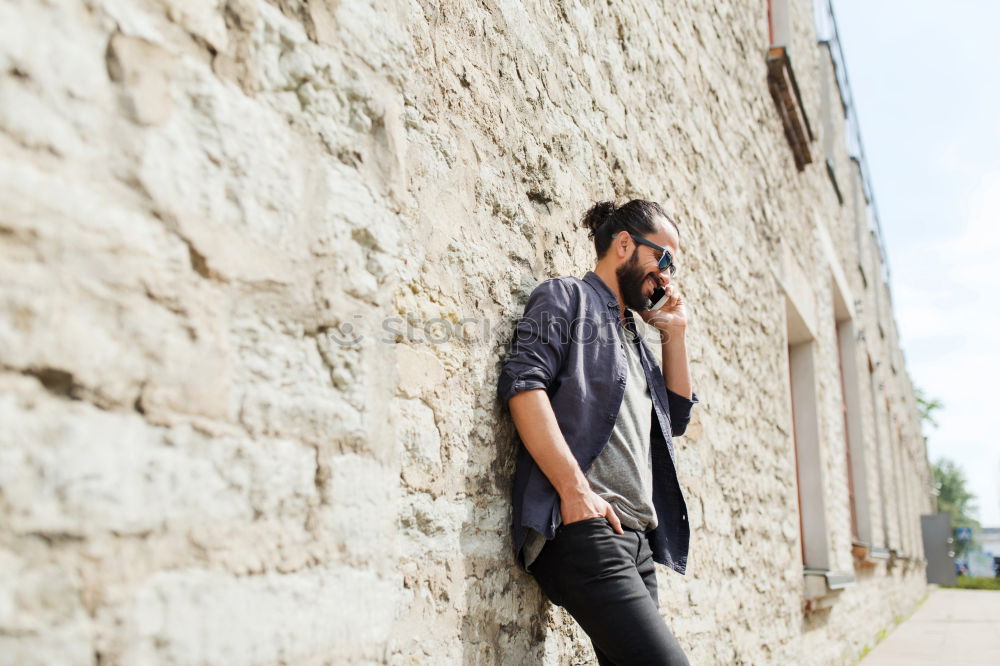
top-left (0, 384), bottom-right (254, 537)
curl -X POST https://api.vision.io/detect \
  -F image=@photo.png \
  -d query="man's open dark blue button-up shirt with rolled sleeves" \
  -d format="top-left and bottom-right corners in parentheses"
top-left (498, 271), bottom-right (698, 573)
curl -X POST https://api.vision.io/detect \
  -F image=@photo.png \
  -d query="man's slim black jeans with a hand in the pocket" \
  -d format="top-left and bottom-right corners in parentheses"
top-left (531, 518), bottom-right (688, 666)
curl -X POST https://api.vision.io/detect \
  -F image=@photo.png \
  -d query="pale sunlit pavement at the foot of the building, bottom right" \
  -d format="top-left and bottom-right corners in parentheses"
top-left (861, 588), bottom-right (1000, 666)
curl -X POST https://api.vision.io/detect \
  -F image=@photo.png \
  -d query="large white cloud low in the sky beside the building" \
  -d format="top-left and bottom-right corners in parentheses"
top-left (893, 171), bottom-right (1000, 525)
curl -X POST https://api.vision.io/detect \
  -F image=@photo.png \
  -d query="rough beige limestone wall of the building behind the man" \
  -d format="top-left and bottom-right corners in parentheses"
top-left (0, 0), bottom-right (930, 665)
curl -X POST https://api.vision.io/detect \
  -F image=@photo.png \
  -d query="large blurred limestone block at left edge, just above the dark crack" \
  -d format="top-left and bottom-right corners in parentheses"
top-left (0, 158), bottom-right (229, 418)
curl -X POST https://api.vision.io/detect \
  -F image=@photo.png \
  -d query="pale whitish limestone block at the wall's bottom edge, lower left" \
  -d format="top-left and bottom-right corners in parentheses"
top-left (107, 566), bottom-right (399, 666)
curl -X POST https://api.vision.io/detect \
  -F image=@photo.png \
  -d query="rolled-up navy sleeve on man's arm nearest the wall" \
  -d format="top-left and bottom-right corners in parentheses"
top-left (497, 279), bottom-right (574, 405)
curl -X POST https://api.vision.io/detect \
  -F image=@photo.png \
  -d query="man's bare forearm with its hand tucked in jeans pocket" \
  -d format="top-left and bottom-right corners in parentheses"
top-left (507, 389), bottom-right (625, 534)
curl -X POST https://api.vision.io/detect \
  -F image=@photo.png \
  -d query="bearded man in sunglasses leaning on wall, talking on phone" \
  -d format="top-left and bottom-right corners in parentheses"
top-left (498, 200), bottom-right (698, 664)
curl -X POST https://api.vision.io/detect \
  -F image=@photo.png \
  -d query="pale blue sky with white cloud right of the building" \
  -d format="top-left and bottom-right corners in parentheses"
top-left (833, 0), bottom-right (1000, 526)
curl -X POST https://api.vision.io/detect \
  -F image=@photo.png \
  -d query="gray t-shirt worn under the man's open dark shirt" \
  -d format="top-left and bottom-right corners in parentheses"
top-left (524, 326), bottom-right (657, 569)
